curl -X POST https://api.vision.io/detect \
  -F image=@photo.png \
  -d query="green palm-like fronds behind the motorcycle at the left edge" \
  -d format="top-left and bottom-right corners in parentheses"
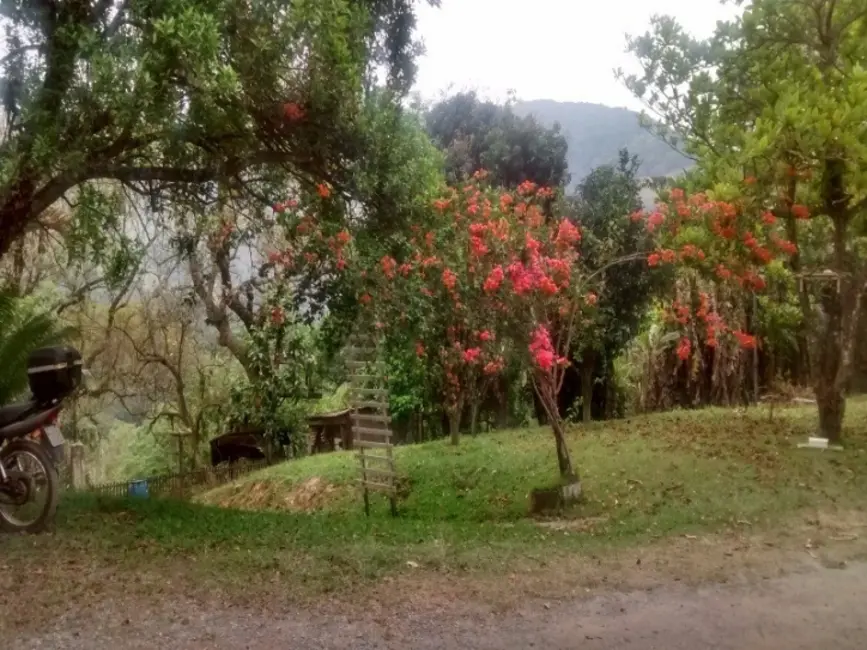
top-left (0, 291), bottom-right (71, 405)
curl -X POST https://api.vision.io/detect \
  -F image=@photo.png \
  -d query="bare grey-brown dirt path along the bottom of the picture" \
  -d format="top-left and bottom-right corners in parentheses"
top-left (11, 564), bottom-right (867, 650)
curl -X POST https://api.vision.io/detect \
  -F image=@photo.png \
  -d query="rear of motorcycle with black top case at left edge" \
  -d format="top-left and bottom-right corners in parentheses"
top-left (0, 346), bottom-right (82, 533)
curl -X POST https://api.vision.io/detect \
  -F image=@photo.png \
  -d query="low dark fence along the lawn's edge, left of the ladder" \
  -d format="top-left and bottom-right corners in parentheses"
top-left (87, 460), bottom-right (269, 498)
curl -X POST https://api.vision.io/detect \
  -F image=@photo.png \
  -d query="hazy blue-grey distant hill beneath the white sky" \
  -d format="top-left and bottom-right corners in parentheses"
top-left (515, 99), bottom-right (692, 185)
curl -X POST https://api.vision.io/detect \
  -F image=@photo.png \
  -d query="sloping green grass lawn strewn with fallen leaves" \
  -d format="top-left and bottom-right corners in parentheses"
top-left (0, 398), bottom-right (867, 608)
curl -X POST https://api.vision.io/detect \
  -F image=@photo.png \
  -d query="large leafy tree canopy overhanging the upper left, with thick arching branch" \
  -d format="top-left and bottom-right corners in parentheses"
top-left (0, 0), bottom-right (434, 256)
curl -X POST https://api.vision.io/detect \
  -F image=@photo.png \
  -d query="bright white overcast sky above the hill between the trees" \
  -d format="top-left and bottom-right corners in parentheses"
top-left (415, 0), bottom-right (735, 110)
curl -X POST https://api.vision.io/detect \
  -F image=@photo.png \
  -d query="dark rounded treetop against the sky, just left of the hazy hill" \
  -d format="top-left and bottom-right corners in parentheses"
top-left (426, 92), bottom-right (569, 189)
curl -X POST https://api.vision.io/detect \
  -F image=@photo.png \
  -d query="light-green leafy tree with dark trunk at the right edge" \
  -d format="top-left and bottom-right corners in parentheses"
top-left (624, 0), bottom-right (867, 442)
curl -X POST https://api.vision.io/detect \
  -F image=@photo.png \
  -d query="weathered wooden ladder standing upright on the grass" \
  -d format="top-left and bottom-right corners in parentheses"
top-left (344, 334), bottom-right (397, 516)
